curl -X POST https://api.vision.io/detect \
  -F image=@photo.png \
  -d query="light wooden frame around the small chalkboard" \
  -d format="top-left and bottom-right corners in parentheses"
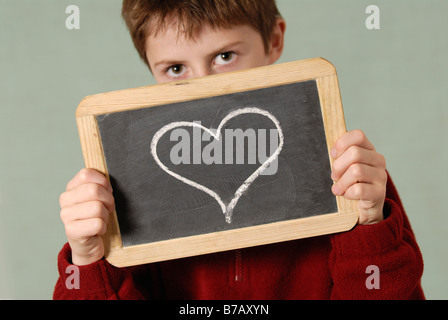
top-left (76, 58), bottom-right (358, 267)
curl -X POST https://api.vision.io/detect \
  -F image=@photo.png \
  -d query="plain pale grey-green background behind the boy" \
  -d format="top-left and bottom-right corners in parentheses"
top-left (0, 0), bottom-right (448, 299)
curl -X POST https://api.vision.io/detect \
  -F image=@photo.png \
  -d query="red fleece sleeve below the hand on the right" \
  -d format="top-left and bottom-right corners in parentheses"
top-left (329, 172), bottom-right (424, 300)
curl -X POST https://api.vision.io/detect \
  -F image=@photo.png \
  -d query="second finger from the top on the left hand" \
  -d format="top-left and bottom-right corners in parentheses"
top-left (59, 183), bottom-right (115, 212)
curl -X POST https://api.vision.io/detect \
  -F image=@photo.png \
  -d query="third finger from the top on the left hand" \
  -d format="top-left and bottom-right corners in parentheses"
top-left (61, 201), bottom-right (110, 225)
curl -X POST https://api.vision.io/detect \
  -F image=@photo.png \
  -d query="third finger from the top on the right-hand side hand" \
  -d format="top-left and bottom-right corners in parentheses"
top-left (332, 163), bottom-right (387, 196)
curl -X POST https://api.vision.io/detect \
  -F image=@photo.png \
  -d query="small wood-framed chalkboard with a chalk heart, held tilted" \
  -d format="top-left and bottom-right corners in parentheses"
top-left (77, 58), bottom-right (358, 267)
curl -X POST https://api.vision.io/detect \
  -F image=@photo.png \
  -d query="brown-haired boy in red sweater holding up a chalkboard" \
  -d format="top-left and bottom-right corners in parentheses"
top-left (54, 0), bottom-right (424, 299)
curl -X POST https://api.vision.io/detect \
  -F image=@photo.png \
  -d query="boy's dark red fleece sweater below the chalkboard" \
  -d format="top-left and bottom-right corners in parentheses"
top-left (53, 174), bottom-right (424, 300)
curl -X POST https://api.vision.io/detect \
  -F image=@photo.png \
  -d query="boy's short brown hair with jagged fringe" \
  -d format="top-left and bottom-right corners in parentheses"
top-left (122, 0), bottom-right (280, 66)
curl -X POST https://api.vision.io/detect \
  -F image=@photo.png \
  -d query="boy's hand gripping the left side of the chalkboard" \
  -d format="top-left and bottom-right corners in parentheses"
top-left (59, 169), bottom-right (115, 265)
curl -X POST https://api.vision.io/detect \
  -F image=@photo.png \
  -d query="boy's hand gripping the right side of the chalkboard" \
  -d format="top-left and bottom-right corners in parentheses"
top-left (331, 130), bottom-right (387, 224)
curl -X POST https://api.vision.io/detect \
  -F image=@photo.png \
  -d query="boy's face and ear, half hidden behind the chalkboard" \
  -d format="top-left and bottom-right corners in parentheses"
top-left (146, 18), bottom-right (285, 83)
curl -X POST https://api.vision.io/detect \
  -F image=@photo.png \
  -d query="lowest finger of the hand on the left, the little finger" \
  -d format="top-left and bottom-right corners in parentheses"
top-left (65, 218), bottom-right (107, 241)
